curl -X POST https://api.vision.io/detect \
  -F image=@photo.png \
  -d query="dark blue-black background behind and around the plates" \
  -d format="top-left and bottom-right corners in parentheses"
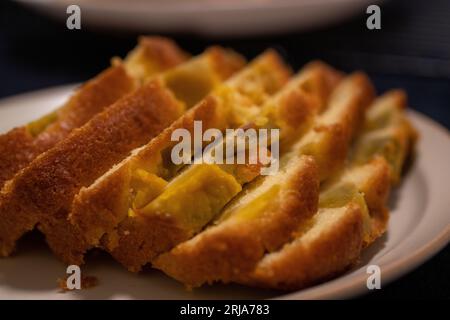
top-left (0, 0), bottom-right (450, 298)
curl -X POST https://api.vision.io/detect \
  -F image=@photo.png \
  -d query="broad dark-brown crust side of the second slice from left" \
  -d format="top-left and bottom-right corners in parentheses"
top-left (0, 81), bottom-right (182, 262)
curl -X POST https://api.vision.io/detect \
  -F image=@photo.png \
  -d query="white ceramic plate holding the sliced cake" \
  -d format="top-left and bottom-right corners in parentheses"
top-left (0, 86), bottom-right (450, 299)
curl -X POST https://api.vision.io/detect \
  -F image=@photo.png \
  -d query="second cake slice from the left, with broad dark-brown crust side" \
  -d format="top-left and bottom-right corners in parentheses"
top-left (0, 47), bottom-right (243, 263)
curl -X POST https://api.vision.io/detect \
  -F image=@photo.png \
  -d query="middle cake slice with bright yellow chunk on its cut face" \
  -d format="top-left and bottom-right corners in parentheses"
top-left (70, 51), bottom-right (289, 271)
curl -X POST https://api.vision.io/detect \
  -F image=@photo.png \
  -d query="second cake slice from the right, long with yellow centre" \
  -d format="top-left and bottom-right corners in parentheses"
top-left (154, 72), bottom-right (373, 286)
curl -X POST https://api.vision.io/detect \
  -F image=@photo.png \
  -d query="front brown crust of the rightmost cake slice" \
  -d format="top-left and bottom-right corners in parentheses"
top-left (239, 204), bottom-right (363, 290)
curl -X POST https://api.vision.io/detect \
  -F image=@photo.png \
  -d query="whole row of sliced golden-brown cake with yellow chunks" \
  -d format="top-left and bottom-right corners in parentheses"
top-left (0, 37), bottom-right (418, 290)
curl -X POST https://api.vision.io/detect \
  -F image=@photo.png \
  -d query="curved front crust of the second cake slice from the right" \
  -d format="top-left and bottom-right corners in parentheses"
top-left (154, 157), bottom-right (319, 286)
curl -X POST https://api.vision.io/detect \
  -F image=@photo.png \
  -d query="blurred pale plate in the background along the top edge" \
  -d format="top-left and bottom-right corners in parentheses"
top-left (16, 0), bottom-right (379, 36)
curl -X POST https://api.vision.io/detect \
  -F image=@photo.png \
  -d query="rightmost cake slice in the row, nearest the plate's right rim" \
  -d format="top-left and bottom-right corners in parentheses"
top-left (238, 91), bottom-right (417, 290)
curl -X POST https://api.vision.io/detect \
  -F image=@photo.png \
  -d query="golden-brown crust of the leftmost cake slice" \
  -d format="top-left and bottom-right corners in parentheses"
top-left (0, 66), bottom-right (135, 186)
